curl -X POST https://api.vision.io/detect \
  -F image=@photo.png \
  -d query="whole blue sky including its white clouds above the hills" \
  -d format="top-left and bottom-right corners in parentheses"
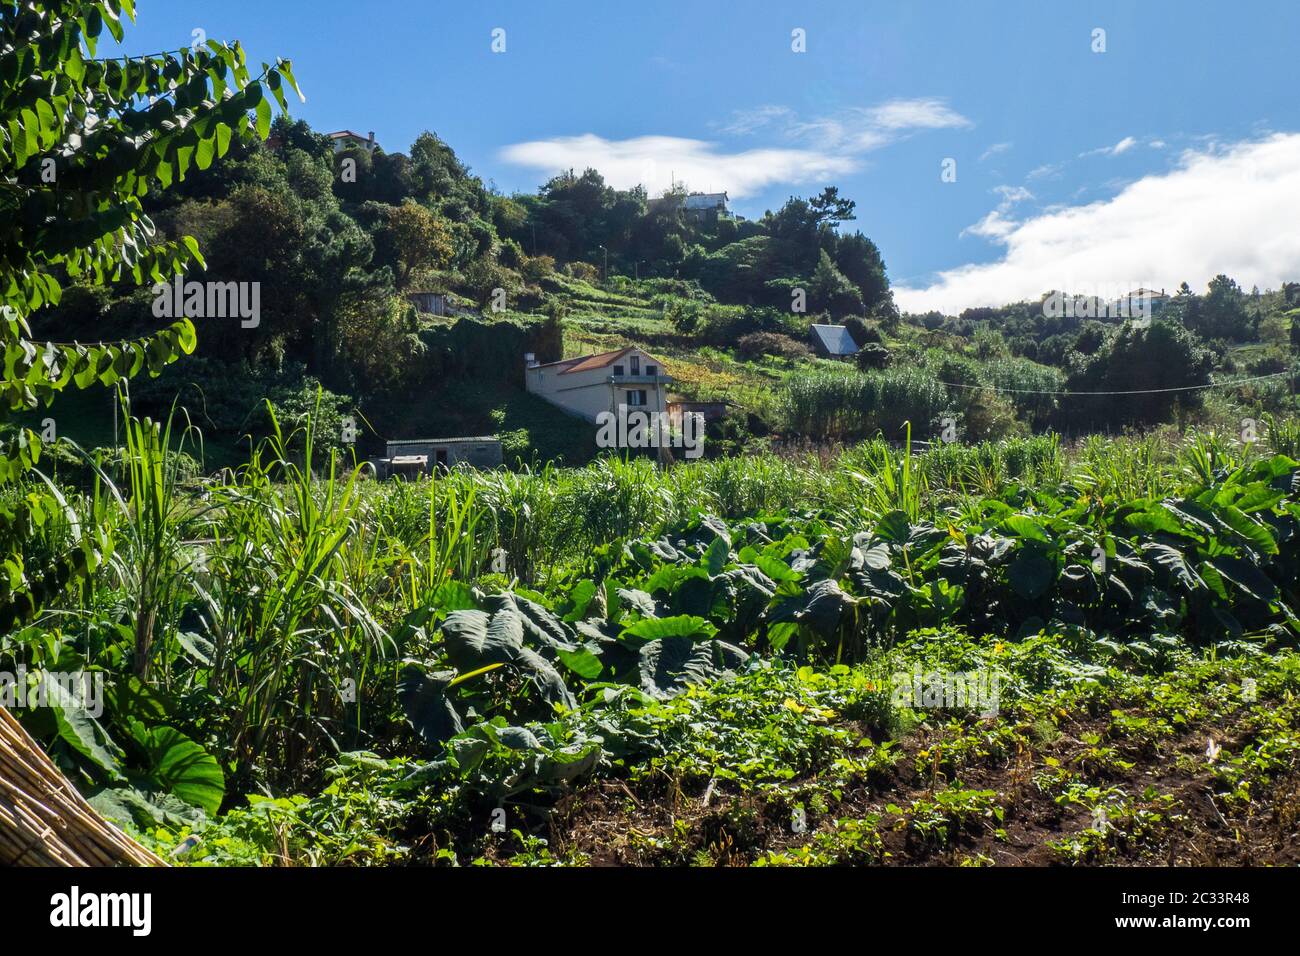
top-left (114, 0), bottom-right (1300, 310)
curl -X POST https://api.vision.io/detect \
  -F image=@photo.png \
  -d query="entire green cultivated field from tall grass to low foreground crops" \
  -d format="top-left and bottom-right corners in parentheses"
top-left (0, 419), bottom-right (1300, 864)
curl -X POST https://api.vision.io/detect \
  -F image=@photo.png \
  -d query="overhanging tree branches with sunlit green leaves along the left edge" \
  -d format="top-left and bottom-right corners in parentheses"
top-left (0, 0), bottom-right (302, 631)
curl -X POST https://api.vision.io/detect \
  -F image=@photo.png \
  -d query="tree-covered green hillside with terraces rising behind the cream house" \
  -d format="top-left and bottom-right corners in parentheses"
top-left (22, 118), bottom-right (1300, 467)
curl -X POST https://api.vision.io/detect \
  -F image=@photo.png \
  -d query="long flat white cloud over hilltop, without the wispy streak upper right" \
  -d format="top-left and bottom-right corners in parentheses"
top-left (502, 133), bottom-right (858, 199)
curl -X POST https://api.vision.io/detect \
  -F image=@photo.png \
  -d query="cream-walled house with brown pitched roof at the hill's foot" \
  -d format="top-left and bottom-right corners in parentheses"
top-left (524, 346), bottom-right (672, 421)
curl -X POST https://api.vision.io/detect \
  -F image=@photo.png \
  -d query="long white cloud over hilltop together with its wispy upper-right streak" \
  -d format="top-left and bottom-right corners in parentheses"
top-left (501, 99), bottom-right (971, 199)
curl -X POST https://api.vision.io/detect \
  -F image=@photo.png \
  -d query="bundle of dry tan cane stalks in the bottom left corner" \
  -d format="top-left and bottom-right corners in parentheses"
top-left (0, 706), bottom-right (166, 866)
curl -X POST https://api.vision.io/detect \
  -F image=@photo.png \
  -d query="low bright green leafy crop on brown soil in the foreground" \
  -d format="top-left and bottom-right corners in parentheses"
top-left (162, 631), bottom-right (1300, 865)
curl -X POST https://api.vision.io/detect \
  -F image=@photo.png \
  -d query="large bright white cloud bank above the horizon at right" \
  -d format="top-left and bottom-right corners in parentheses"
top-left (894, 133), bottom-right (1300, 312)
